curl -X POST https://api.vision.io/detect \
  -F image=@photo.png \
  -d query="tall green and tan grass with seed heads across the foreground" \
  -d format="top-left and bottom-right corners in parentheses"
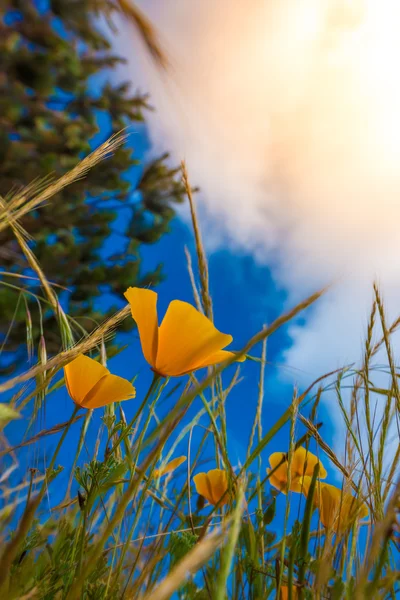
top-left (0, 137), bottom-right (400, 600)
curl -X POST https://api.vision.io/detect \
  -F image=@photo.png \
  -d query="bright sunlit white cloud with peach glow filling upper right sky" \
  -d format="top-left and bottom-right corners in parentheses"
top-left (119, 0), bottom-right (400, 384)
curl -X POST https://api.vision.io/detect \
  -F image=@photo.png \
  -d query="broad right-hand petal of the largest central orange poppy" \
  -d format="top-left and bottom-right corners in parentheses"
top-left (156, 300), bottom-right (232, 377)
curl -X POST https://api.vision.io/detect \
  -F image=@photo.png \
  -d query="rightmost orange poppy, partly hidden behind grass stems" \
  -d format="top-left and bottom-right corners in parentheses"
top-left (303, 477), bottom-right (368, 532)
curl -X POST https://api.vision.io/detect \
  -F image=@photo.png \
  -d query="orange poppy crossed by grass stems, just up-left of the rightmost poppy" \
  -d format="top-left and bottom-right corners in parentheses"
top-left (267, 446), bottom-right (327, 494)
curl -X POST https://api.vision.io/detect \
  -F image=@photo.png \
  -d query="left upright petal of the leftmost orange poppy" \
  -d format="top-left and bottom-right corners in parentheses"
top-left (64, 354), bottom-right (110, 404)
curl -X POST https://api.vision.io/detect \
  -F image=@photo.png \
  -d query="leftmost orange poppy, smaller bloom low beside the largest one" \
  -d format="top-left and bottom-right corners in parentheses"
top-left (64, 354), bottom-right (136, 408)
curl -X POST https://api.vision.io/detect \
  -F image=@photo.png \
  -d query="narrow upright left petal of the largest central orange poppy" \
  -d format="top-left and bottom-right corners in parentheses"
top-left (124, 287), bottom-right (158, 367)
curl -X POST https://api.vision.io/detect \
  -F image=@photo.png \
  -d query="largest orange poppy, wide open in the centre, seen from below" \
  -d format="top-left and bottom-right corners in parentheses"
top-left (124, 287), bottom-right (244, 377)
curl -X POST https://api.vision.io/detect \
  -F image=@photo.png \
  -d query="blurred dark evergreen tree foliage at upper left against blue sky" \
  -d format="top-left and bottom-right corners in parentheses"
top-left (0, 0), bottom-right (183, 372)
